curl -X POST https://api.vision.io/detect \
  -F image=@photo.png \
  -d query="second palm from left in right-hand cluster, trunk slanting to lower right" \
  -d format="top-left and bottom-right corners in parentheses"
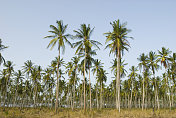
top-left (148, 51), bottom-right (159, 109)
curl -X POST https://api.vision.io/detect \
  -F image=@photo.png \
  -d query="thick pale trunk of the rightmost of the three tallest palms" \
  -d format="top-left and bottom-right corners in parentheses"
top-left (116, 49), bottom-right (120, 112)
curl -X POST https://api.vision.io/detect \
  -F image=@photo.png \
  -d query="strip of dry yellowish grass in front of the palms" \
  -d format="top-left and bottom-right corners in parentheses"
top-left (0, 108), bottom-right (176, 118)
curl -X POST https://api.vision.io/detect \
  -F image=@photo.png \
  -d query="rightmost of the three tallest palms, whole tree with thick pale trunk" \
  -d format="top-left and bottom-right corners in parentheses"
top-left (104, 19), bottom-right (132, 112)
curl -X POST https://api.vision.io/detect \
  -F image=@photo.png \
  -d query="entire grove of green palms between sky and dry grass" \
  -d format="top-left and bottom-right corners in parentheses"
top-left (0, 19), bottom-right (176, 112)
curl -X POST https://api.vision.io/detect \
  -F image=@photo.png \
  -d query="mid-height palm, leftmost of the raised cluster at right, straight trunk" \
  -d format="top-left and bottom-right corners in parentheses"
top-left (137, 53), bottom-right (148, 110)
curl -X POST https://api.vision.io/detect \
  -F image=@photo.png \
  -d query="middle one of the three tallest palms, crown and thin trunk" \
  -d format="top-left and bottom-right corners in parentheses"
top-left (73, 24), bottom-right (101, 111)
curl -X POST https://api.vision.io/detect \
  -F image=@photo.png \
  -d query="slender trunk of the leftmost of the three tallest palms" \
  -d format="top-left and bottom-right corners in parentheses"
top-left (55, 46), bottom-right (60, 113)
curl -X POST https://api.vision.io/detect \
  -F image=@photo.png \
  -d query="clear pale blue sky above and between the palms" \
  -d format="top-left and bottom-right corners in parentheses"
top-left (0, 0), bottom-right (176, 83)
